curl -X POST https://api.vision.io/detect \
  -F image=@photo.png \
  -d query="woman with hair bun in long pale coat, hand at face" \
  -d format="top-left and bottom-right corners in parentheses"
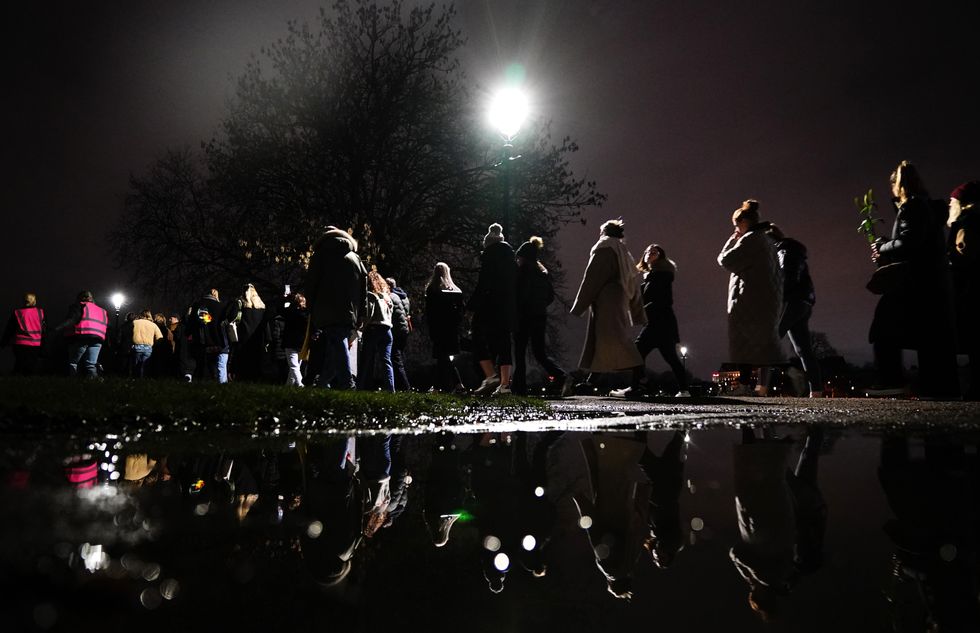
top-left (718, 200), bottom-right (783, 396)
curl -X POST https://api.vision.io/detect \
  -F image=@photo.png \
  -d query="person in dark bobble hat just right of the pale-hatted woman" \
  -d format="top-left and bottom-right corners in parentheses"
top-left (511, 237), bottom-right (572, 396)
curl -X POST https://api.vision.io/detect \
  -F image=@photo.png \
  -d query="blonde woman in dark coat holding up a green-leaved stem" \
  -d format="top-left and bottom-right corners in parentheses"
top-left (868, 161), bottom-right (959, 397)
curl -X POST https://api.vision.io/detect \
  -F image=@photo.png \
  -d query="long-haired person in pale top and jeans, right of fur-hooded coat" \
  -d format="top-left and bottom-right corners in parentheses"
top-left (357, 270), bottom-right (395, 392)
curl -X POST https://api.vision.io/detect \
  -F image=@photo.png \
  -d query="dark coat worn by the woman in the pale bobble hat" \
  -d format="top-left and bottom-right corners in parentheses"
top-left (467, 242), bottom-right (517, 332)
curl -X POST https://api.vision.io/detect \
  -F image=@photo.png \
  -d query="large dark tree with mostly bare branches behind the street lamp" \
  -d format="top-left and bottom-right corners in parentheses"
top-left (112, 0), bottom-right (604, 306)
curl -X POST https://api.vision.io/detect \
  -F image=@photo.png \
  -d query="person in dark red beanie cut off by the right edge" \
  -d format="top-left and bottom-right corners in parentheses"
top-left (946, 181), bottom-right (980, 400)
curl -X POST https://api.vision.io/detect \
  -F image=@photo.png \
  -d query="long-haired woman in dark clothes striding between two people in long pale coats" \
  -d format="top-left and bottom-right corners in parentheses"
top-left (612, 244), bottom-right (691, 398)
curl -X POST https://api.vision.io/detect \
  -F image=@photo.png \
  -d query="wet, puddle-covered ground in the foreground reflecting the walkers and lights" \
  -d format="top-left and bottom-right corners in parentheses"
top-left (0, 397), bottom-right (980, 632)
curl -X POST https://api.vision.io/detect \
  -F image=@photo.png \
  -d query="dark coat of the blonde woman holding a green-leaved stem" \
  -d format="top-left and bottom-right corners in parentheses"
top-left (868, 196), bottom-right (953, 349)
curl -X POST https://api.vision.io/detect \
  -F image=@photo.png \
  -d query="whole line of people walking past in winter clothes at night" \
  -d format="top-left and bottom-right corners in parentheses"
top-left (2, 161), bottom-right (980, 398)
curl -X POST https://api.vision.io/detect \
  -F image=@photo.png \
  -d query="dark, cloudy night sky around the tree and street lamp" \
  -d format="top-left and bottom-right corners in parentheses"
top-left (0, 0), bottom-right (980, 377)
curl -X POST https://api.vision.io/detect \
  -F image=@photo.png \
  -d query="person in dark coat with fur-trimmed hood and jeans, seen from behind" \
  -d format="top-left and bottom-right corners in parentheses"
top-left (304, 227), bottom-right (367, 389)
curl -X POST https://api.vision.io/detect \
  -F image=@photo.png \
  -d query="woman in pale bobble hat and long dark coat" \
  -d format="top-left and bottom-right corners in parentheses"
top-left (467, 223), bottom-right (517, 396)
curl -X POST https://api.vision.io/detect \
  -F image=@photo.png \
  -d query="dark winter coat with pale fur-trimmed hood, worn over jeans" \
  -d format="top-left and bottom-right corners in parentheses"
top-left (305, 229), bottom-right (367, 329)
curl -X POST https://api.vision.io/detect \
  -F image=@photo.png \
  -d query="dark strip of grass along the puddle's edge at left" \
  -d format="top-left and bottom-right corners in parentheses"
top-left (0, 377), bottom-right (548, 434)
